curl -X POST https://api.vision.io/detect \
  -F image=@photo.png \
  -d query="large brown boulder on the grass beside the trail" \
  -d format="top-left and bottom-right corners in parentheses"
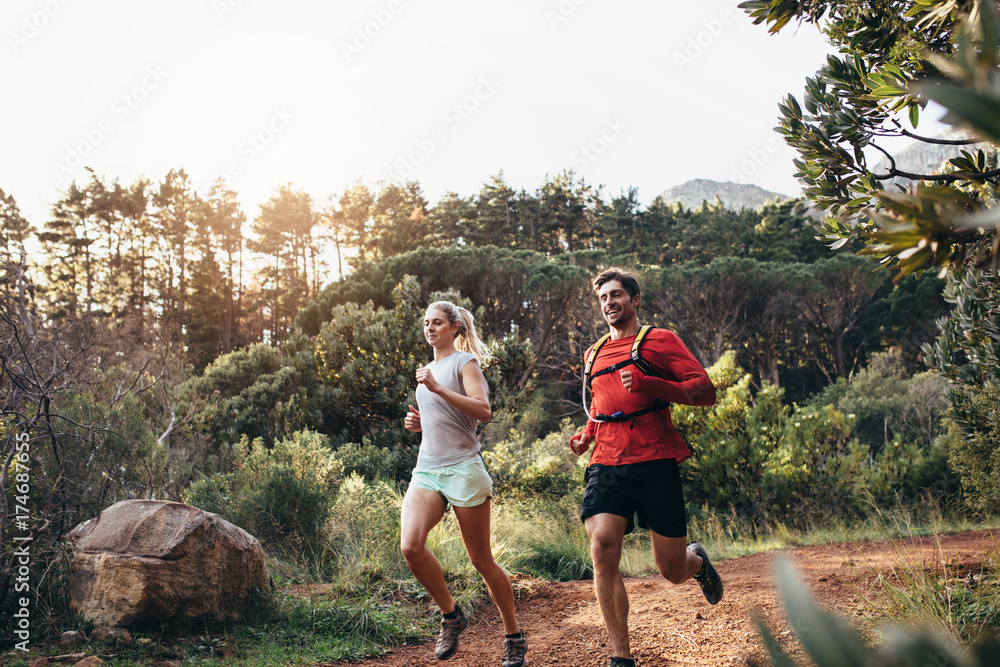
top-left (69, 500), bottom-right (269, 629)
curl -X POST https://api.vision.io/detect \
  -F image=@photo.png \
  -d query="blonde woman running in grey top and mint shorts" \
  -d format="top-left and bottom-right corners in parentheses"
top-left (400, 301), bottom-right (528, 667)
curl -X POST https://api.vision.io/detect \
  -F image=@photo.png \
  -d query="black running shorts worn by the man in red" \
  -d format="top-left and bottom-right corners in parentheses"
top-left (580, 459), bottom-right (687, 537)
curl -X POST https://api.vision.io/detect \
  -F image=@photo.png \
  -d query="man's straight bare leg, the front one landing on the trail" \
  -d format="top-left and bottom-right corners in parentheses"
top-left (584, 514), bottom-right (632, 658)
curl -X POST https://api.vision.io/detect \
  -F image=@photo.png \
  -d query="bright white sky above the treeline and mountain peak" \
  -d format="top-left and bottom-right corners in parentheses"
top-left (0, 0), bottom-right (936, 227)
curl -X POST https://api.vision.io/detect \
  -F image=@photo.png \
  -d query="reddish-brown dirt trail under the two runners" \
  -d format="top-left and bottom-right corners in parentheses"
top-left (326, 531), bottom-right (1000, 667)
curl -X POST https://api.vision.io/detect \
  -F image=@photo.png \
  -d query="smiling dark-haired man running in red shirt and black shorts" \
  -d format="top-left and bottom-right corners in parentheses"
top-left (569, 268), bottom-right (722, 667)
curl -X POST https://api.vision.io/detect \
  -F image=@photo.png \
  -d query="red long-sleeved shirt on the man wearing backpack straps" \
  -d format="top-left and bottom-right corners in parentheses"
top-left (581, 329), bottom-right (715, 466)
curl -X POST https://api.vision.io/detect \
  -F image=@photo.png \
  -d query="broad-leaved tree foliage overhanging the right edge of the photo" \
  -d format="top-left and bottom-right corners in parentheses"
top-left (740, 0), bottom-right (1000, 507)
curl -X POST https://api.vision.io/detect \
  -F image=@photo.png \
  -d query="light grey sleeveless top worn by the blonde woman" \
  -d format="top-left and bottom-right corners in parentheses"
top-left (416, 352), bottom-right (489, 470)
